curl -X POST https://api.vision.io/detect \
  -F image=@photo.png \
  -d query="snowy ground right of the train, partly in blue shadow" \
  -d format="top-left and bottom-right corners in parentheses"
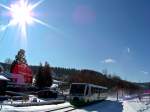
top-left (72, 99), bottom-right (150, 112)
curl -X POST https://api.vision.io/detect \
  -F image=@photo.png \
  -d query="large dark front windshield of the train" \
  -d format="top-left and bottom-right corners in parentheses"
top-left (70, 84), bottom-right (85, 95)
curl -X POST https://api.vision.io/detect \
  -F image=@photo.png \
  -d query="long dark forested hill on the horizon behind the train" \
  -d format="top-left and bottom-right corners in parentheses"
top-left (0, 63), bottom-right (143, 91)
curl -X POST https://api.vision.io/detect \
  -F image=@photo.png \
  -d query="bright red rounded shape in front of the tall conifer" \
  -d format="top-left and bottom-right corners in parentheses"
top-left (12, 64), bottom-right (32, 83)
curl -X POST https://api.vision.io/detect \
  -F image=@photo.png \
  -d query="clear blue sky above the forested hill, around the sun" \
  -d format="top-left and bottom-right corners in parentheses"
top-left (0, 0), bottom-right (150, 82)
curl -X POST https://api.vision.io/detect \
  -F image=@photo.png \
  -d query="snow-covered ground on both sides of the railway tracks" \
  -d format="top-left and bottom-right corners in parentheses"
top-left (1, 98), bottom-right (150, 112)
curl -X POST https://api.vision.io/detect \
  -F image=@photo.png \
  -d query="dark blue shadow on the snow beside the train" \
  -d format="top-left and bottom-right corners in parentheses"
top-left (77, 100), bottom-right (123, 112)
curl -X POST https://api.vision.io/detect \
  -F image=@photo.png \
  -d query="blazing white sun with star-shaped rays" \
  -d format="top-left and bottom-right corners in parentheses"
top-left (0, 0), bottom-right (49, 38)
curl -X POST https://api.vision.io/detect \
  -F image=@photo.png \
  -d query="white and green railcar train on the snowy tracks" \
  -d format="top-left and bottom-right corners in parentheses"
top-left (69, 83), bottom-right (108, 106)
